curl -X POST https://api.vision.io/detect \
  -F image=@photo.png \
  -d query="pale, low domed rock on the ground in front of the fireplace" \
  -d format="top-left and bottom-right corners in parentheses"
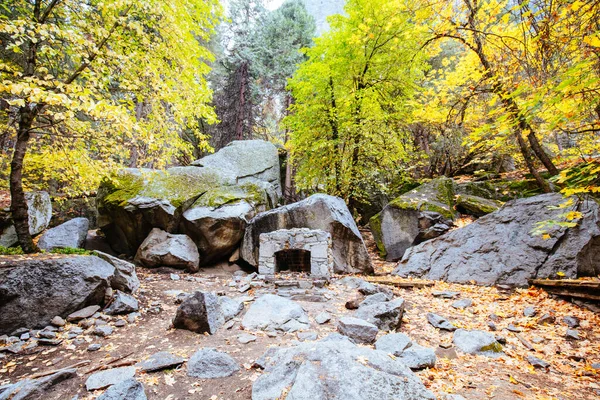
top-left (242, 294), bottom-right (309, 332)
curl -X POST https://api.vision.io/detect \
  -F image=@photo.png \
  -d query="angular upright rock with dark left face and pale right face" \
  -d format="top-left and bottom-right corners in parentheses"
top-left (173, 292), bottom-right (225, 335)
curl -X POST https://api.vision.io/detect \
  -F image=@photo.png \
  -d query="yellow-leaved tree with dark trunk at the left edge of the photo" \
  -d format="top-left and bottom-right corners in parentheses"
top-left (0, 0), bottom-right (219, 252)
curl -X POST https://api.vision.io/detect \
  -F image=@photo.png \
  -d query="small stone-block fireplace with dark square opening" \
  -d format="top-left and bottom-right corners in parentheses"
top-left (258, 228), bottom-right (333, 277)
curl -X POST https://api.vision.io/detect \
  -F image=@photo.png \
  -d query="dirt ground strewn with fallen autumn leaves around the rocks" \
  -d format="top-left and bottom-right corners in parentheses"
top-left (0, 231), bottom-right (600, 400)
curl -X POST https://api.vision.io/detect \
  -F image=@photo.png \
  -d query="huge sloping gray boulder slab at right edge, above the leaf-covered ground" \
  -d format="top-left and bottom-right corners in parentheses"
top-left (394, 194), bottom-right (600, 286)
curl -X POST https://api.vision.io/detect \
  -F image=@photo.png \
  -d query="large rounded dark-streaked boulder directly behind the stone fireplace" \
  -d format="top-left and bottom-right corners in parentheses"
top-left (241, 194), bottom-right (373, 273)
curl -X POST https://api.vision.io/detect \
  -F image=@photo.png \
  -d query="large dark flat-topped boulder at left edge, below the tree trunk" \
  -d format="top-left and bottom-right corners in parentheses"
top-left (0, 256), bottom-right (115, 334)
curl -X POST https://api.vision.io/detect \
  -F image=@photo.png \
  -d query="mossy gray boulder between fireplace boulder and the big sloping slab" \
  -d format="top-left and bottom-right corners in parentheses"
top-left (369, 178), bottom-right (456, 261)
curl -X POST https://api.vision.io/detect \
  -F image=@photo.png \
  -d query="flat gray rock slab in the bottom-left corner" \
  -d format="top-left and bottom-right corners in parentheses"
top-left (0, 368), bottom-right (77, 400)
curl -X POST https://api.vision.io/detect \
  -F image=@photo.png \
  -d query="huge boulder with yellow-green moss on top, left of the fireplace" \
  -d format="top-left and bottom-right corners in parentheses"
top-left (97, 141), bottom-right (281, 264)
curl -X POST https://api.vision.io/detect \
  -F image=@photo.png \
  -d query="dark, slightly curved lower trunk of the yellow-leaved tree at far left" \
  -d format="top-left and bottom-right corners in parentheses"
top-left (10, 105), bottom-right (39, 253)
